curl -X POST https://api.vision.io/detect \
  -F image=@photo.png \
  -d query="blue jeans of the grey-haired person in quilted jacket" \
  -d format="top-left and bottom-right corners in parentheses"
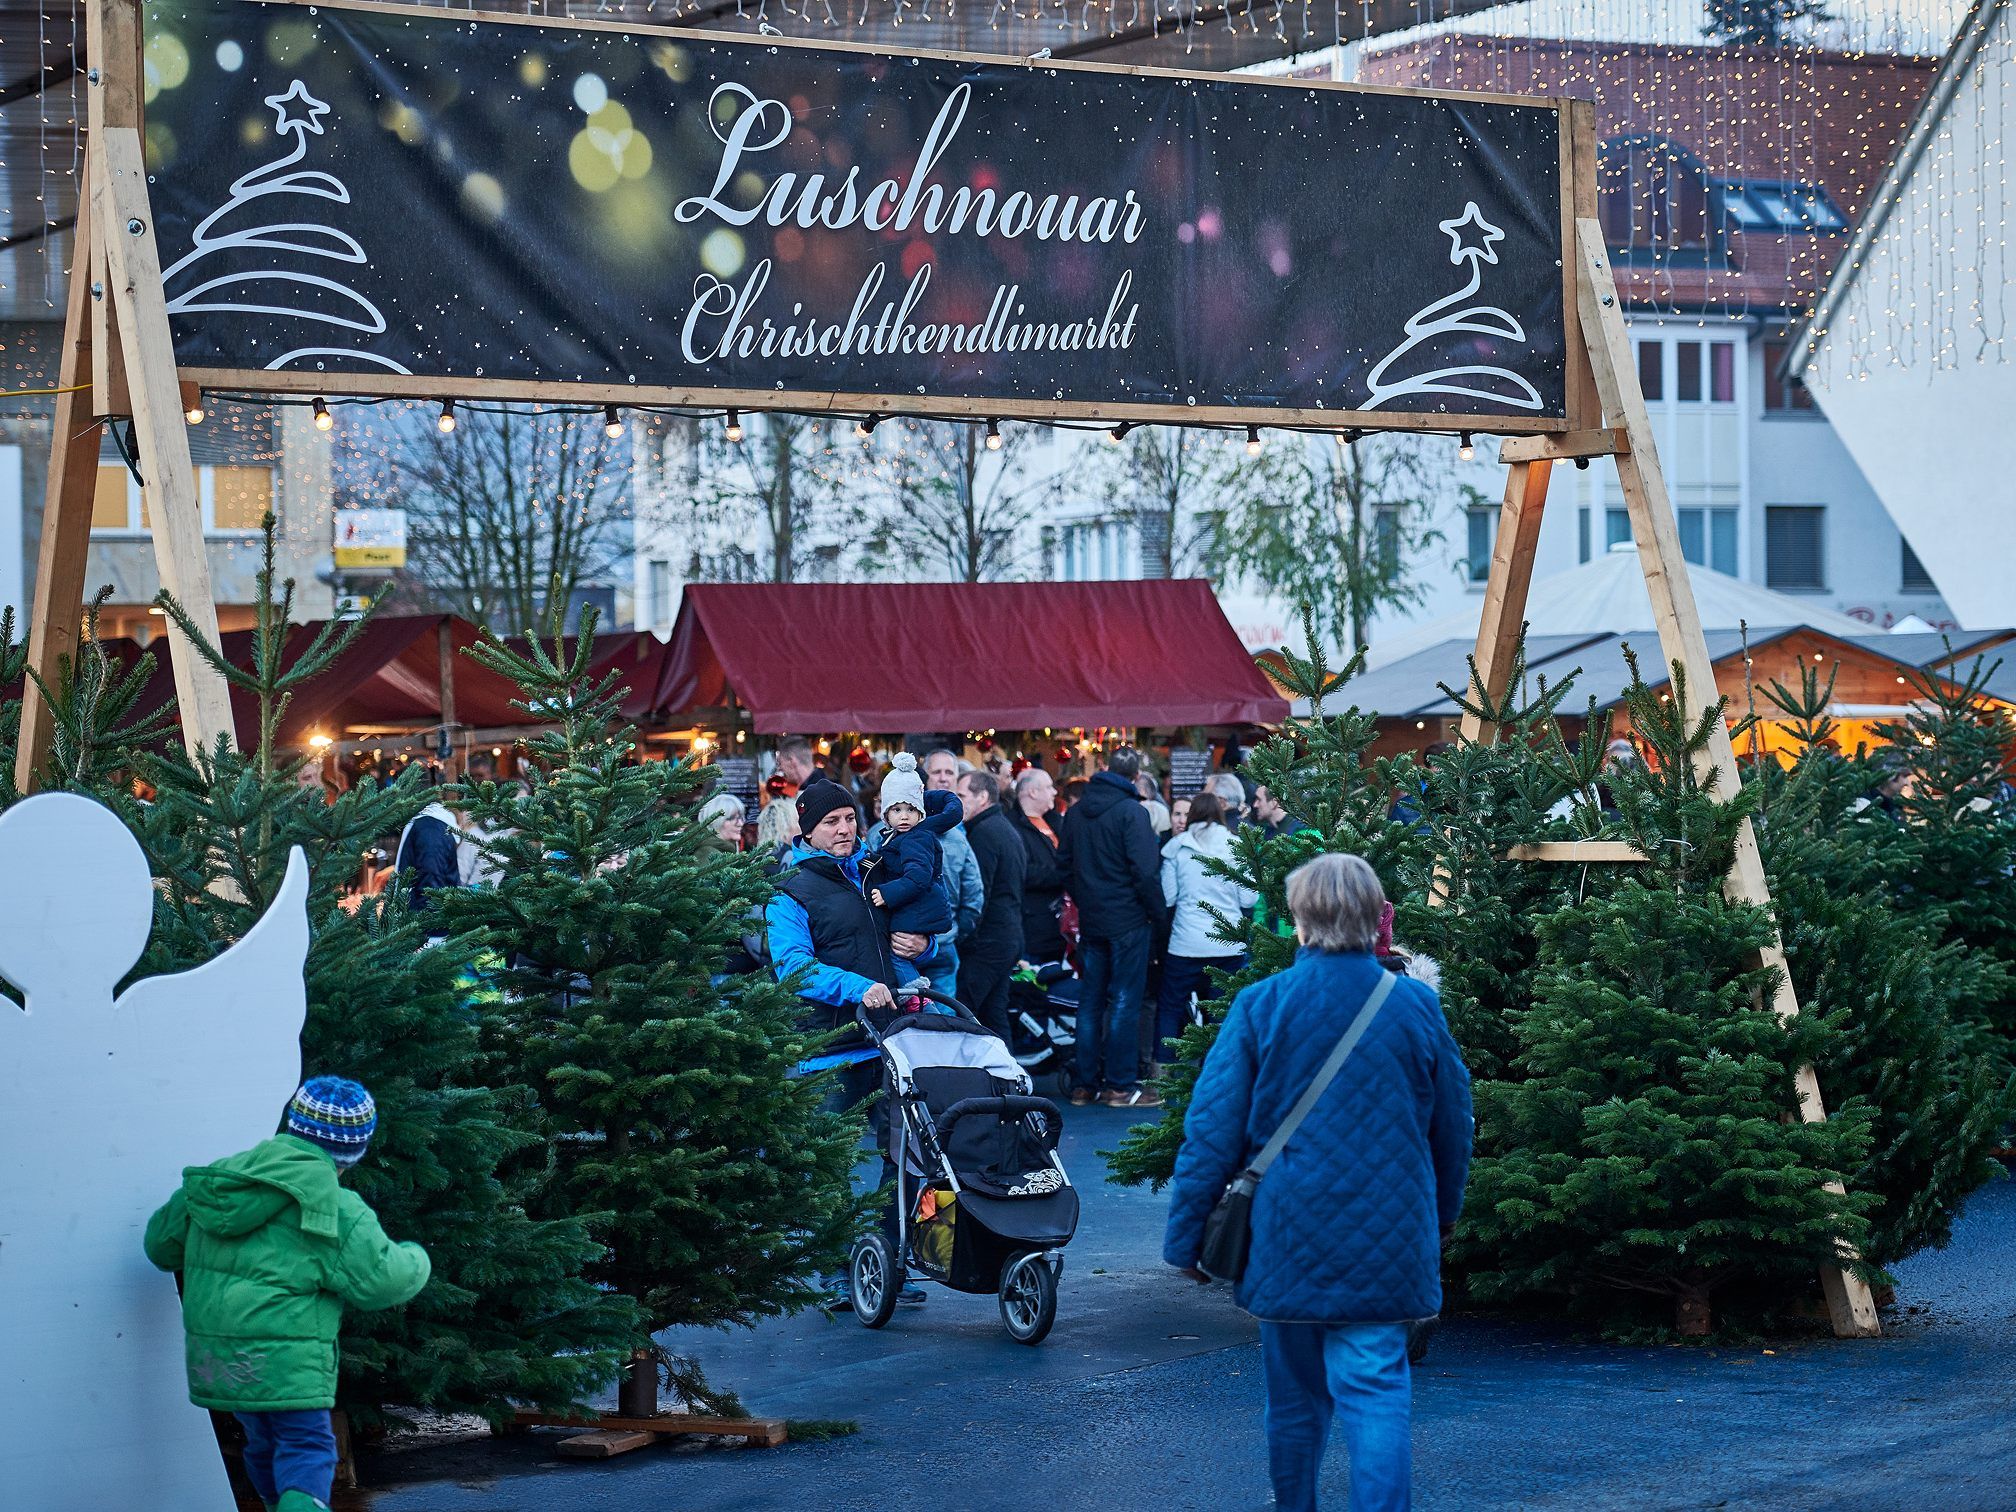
top-left (1260, 1322), bottom-right (1413, 1512)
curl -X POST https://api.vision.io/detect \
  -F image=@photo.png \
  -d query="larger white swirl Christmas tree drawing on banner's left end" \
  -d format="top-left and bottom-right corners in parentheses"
top-left (161, 79), bottom-right (407, 373)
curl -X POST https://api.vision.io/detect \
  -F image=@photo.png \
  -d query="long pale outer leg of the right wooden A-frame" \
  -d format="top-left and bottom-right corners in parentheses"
top-left (1574, 218), bottom-right (1883, 1339)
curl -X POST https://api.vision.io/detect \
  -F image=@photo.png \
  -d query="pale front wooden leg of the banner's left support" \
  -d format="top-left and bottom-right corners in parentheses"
top-left (89, 130), bottom-right (234, 752)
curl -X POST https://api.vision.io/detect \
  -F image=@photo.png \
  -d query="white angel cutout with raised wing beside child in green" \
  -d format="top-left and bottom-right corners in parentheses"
top-left (0, 792), bottom-right (308, 1512)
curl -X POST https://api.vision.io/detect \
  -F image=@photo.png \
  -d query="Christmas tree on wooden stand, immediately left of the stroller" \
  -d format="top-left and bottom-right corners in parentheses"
top-left (442, 613), bottom-right (861, 1397)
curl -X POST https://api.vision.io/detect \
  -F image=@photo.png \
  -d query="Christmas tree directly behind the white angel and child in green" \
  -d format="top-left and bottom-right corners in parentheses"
top-left (139, 516), bottom-right (635, 1427)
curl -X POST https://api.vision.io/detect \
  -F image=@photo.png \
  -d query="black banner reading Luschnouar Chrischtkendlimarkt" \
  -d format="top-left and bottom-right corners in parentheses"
top-left (145, 0), bottom-right (1566, 423)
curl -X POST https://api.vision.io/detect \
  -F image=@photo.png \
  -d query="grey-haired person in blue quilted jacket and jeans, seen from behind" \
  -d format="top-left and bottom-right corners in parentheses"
top-left (1163, 855), bottom-right (1472, 1512)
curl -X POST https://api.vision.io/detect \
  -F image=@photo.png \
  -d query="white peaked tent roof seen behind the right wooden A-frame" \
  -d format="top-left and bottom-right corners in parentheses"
top-left (1365, 544), bottom-right (1869, 667)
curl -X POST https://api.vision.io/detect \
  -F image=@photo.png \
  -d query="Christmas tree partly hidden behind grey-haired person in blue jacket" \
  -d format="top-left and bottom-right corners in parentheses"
top-left (1113, 617), bottom-right (1427, 1187)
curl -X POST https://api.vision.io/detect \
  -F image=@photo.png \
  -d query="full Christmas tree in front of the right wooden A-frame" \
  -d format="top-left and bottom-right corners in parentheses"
top-left (1462, 667), bottom-right (1877, 1333)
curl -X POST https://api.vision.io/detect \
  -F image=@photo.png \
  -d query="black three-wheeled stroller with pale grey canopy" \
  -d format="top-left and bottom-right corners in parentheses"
top-left (847, 990), bottom-right (1079, 1345)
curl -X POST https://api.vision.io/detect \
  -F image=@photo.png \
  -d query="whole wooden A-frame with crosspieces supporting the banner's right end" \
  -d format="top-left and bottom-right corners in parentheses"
top-left (1429, 218), bottom-right (1881, 1339)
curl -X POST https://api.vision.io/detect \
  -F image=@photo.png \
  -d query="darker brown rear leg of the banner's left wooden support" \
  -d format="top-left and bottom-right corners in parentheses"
top-left (14, 192), bottom-right (103, 792)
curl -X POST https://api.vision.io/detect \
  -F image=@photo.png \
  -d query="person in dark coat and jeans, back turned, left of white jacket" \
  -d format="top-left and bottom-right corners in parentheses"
top-left (1058, 746), bottom-right (1165, 1107)
